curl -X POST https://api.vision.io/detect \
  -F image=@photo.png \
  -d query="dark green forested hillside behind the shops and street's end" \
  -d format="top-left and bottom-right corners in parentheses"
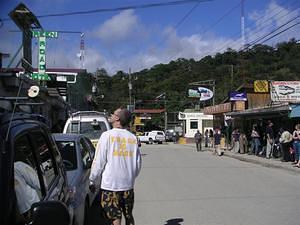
top-left (73, 39), bottom-right (300, 112)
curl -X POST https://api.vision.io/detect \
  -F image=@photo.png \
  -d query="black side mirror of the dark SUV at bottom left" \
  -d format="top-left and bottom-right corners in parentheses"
top-left (31, 201), bottom-right (71, 225)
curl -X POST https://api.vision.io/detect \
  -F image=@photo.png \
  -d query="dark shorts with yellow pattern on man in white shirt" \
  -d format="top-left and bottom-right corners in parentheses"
top-left (101, 189), bottom-right (134, 224)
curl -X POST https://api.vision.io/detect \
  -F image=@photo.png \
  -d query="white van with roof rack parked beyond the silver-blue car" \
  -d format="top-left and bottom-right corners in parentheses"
top-left (63, 111), bottom-right (111, 148)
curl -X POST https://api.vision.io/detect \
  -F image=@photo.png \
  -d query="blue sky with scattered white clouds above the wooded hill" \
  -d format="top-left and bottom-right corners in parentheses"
top-left (0, 0), bottom-right (300, 74)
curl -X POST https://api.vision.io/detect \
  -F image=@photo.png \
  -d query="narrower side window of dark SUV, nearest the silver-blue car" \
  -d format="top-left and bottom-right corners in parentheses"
top-left (32, 132), bottom-right (58, 187)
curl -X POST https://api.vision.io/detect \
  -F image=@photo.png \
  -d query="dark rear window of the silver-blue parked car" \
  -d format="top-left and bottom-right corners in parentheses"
top-left (56, 141), bottom-right (77, 171)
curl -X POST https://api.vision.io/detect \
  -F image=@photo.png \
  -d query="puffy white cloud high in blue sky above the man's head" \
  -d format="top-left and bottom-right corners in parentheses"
top-left (93, 10), bottom-right (140, 43)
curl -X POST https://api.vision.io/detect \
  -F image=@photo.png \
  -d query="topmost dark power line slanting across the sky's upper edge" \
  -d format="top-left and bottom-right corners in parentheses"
top-left (3, 0), bottom-right (212, 21)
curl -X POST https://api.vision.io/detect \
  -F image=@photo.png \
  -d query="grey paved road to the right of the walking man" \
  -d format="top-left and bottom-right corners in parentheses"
top-left (89, 143), bottom-right (300, 225)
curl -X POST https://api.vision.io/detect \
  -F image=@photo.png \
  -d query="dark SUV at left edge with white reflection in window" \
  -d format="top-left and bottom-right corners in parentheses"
top-left (0, 113), bottom-right (72, 225)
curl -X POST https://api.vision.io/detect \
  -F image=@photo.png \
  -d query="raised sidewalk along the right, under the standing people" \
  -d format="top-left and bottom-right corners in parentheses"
top-left (182, 143), bottom-right (300, 174)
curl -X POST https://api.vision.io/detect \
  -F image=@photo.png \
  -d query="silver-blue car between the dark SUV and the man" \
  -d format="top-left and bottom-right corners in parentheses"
top-left (53, 134), bottom-right (96, 225)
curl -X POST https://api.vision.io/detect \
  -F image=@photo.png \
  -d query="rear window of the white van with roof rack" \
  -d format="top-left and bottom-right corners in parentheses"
top-left (67, 121), bottom-right (107, 139)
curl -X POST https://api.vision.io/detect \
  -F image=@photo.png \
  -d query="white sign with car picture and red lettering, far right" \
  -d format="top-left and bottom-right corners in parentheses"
top-left (270, 81), bottom-right (300, 102)
